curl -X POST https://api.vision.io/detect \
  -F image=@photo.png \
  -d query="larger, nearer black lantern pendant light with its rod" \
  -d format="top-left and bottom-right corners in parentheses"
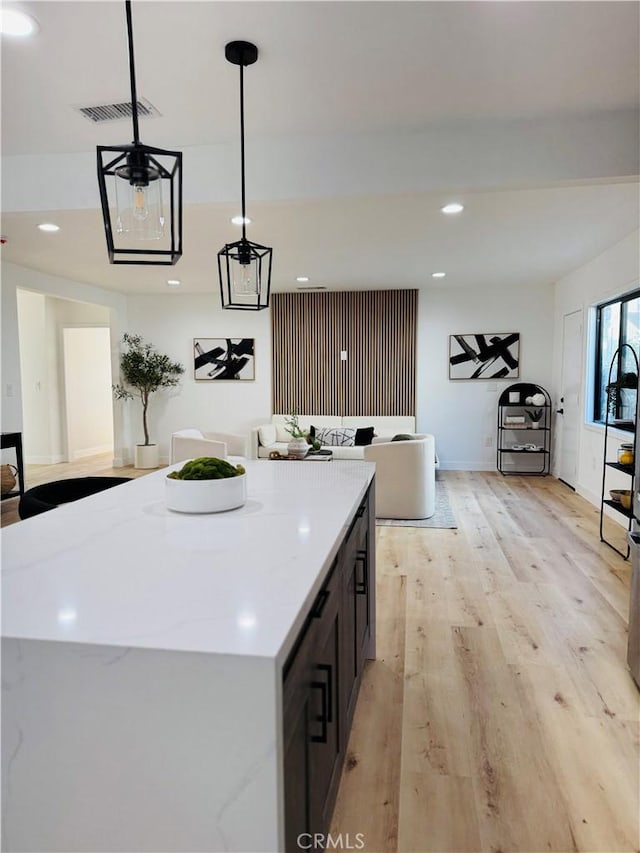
top-left (97, 0), bottom-right (182, 265)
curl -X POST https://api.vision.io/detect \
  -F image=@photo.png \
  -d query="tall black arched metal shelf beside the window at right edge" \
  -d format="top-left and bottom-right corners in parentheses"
top-left (600, 344), bottom-right (638, 560)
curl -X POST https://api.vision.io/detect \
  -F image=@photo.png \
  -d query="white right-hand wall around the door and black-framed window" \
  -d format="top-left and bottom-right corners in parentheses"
top-left (553, 231), bottom-right (640, 506)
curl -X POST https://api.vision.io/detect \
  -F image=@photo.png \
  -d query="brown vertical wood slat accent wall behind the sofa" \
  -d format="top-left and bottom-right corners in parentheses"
top-left (271, 290), bottom-right (418, 415)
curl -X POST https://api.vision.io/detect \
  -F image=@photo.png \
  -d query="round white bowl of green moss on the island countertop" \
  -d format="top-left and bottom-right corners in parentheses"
top-left (165, 456), bottom-right (247, 513)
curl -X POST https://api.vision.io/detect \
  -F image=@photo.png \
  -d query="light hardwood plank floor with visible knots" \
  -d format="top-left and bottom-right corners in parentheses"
top-left (2, 456), bottom-right (640, 853)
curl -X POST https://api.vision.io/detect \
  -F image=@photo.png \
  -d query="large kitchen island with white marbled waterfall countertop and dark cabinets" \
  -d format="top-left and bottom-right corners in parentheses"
top-left (2, 461), bottom-right (375, 853)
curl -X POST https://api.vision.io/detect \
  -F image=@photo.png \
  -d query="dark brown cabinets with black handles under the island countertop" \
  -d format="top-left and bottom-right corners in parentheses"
top-left (283, 484), bottom-right (375, 851)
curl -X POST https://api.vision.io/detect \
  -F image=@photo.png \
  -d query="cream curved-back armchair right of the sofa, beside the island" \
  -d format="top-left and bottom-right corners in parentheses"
top-left (364, 435), bottom-right (436, 518)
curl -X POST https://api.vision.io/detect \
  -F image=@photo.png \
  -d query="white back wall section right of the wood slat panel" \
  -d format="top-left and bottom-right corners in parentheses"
top-left (417, 284), bottom-right (553, 471)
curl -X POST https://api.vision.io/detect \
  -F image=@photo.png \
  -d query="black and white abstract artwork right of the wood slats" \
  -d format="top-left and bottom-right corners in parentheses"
top-left (449, 332), bottom-right (520, 379)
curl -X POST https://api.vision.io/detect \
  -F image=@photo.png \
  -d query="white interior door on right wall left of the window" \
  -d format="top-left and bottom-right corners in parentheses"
top-left (556, 310), bottom-right (582, 489)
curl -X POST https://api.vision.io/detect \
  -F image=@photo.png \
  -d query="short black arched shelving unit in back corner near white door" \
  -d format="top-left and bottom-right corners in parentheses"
top-left (496, 382), bottom-right (551, 477)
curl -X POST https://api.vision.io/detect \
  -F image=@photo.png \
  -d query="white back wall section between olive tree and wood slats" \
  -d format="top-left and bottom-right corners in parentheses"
top-left (126, 292), bottom-right (271, 459)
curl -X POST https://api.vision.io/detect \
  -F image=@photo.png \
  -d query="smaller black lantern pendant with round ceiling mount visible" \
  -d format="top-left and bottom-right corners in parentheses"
top-left (218, 41), bottom-right (273, 311)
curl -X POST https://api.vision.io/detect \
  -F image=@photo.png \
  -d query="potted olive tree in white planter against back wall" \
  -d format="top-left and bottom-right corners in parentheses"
top-left (113, 334), bottom-right (184, 468)
